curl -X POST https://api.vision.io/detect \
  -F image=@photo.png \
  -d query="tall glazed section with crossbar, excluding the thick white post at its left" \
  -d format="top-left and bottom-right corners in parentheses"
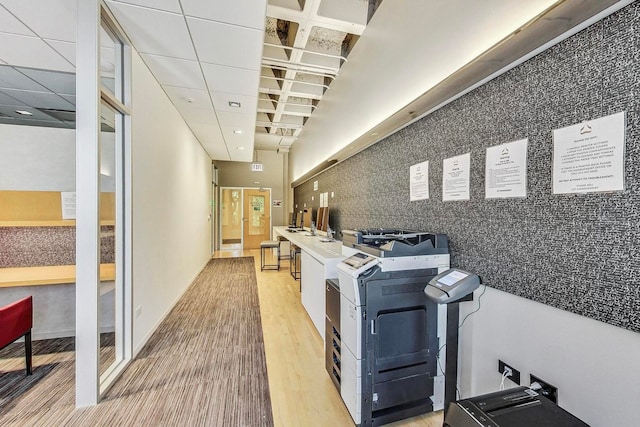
top-left (98, 10), bottom-right (131, 393)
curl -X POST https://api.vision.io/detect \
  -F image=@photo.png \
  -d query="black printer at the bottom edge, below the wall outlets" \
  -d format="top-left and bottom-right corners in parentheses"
top-left (444, 387), bottom-right (589, 427)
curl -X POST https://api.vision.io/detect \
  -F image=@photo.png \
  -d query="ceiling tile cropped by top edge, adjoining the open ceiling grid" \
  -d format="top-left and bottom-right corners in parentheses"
top-left (182, 0), bottom-right (267, 30)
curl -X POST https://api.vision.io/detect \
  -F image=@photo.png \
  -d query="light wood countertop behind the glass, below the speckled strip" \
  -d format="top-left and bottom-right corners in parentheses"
top-left (0, 264), bottom-right (116, 288)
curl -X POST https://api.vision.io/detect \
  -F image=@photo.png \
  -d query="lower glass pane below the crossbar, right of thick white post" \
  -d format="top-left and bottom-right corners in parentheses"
top-left (98, 102), bottom-right (122, 375)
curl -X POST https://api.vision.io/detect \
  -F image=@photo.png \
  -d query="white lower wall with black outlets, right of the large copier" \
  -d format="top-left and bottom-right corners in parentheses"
top-left (459, 288), bottom-right (640, 427)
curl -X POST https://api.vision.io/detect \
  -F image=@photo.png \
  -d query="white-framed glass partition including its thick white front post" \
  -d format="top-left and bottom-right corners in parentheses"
top-left (76, 0), bottom-right (132, 406)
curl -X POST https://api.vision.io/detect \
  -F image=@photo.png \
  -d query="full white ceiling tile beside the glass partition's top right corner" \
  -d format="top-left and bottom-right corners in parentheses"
top-left (111, 3), bottom-right (196, 61)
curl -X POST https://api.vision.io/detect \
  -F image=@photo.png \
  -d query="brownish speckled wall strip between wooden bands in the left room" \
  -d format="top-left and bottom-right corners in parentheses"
top-left (0, 226), bottom-right (115, 268)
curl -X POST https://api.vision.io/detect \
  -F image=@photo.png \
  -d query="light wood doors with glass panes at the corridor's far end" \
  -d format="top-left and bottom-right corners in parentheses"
top-left (220, 188), bottom-right (271, 249)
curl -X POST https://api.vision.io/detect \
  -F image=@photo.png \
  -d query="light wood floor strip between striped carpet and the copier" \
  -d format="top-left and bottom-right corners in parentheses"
top-left (214, 249), bottom-right (442, 427)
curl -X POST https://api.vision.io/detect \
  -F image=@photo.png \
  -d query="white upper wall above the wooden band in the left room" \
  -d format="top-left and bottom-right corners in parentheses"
top-left (0, 124), bottom-right (76, 191)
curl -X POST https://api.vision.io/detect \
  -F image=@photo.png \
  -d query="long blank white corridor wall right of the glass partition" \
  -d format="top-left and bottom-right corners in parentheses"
top-left (131, 53), bottom-right (211, 355)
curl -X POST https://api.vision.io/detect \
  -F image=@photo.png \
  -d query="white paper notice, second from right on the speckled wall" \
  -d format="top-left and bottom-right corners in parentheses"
top-left (484, 139), bottom-right (529, 199)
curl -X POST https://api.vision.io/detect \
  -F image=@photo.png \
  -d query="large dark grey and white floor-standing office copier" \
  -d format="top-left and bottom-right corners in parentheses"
top-left (336, 230), bottom-right (449, 426)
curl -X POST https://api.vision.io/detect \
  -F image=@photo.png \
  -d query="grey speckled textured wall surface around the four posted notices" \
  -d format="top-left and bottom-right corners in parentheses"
top-left (294, 2), bottom-right (640, 332)
